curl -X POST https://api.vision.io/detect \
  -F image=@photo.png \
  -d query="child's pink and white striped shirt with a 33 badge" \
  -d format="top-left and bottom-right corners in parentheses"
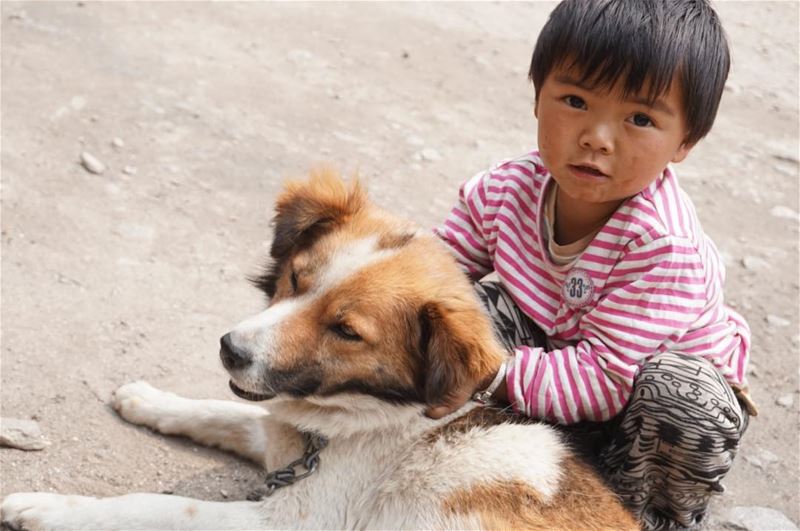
top-left (435, 151), bottom-right (750, 424)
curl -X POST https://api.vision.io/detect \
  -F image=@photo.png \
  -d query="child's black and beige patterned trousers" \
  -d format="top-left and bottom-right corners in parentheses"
top-left (475, 281), bottom-right (748, 529)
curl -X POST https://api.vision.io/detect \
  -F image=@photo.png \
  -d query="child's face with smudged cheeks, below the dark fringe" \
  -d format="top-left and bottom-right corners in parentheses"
top-left (534, 64), bottom-right (691, 206)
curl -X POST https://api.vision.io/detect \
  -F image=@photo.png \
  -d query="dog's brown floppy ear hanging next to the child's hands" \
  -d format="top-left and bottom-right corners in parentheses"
top-left (419, 303), bottom-right (502, 418)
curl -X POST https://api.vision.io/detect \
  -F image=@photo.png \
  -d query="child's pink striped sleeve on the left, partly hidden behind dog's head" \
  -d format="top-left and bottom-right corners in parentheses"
top-left (434, 172), bottom-right (493, 280)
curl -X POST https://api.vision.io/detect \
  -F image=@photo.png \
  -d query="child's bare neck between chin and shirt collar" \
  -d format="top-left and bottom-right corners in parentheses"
top-left (553, 187), bottom-right (624, 245)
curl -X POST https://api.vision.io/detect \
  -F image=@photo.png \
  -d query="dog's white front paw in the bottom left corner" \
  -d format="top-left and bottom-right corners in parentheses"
top-left (0, 492), bottom-right (92, 531)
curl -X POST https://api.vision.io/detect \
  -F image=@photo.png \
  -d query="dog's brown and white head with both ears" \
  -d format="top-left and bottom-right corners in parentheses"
top-left (220, 172), bottom-right (502, 424)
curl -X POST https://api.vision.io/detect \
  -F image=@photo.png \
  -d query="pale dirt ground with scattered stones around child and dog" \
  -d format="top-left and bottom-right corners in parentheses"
top-left (0, 1), bottom-right (800, 526)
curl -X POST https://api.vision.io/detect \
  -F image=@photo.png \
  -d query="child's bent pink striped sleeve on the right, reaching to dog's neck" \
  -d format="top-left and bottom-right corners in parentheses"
top-left (507, 238), bottom-right (706, 424)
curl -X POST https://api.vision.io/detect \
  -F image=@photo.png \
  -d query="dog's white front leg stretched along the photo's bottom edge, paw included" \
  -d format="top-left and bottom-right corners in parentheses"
top-left (0, 492), bottom-right (265, 531)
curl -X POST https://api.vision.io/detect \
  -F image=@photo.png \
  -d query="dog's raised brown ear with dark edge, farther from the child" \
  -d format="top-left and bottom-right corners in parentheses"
top-left (253, 170), bottom-right (366, 297)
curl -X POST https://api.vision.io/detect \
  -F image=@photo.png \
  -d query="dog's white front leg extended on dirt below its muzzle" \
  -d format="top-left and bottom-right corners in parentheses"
top-left (111, 381), bottom-right (268, 465)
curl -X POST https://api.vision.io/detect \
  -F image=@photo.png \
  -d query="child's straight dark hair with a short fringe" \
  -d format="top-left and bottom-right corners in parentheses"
top-left (528, 0), bottom-right (730, 143)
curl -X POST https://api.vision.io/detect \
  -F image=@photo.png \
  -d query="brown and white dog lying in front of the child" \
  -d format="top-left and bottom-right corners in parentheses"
top-left (2, 172), bottom-right (637, 530)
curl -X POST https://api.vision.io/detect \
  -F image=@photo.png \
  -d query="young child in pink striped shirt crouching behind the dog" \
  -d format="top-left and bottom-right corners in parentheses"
top-left (437, 0), bottom-right (756, 528)
